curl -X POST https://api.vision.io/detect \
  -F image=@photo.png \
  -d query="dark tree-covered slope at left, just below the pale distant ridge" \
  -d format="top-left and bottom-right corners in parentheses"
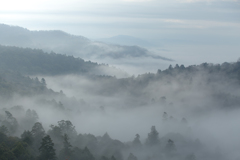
top-left (0, 45), bottom-right (124, 75)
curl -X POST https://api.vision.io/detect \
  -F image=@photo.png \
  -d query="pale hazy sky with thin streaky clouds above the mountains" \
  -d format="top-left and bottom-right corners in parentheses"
top-left (0, 0), bottom-right (240, 68)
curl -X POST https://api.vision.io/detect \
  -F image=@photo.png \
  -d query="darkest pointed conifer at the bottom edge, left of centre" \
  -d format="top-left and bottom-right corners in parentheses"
top-left (37, 135), bottom-right (57, 160)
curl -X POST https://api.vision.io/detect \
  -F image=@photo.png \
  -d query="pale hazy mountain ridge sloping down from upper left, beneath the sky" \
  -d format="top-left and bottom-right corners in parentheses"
top-left (0, 24), bottom-right (172, 61)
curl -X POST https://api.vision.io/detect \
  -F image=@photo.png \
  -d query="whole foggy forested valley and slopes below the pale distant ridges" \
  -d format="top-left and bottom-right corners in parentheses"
top-left (0, 43), bottom-right (240, 160)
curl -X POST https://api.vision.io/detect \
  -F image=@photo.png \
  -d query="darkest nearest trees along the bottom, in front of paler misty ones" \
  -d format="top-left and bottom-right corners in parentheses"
top-left (0, 120), bottom-right (197, 160)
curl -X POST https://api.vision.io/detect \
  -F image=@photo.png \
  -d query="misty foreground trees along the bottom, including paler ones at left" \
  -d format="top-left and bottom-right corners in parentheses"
top-left (0, 107), bottom-right (210, 160)
